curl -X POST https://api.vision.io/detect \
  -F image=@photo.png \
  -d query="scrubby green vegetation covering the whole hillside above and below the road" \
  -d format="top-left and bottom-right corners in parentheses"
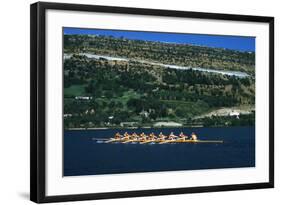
top-left (64, 35), bottom-right (255, 128)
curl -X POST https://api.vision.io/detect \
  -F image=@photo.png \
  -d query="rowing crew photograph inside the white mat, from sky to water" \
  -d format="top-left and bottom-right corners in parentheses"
top-left (62, 27), bottom-right (256, 176)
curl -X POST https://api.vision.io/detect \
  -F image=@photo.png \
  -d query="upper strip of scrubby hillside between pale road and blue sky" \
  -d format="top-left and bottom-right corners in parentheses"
top-left (64, 35), bottom-right (255, 74)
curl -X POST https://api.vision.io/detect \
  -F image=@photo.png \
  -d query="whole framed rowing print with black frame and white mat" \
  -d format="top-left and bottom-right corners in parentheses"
top-left (30, 2), bottom-right (274, 203)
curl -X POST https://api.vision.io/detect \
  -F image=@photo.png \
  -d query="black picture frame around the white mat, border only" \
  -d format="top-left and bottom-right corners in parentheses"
top-left (30, 2), bottom-right (274, 203)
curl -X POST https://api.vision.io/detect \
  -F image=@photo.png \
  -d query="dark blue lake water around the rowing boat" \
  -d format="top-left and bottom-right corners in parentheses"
top-left (63, 127), bottom-right (255, 176)
